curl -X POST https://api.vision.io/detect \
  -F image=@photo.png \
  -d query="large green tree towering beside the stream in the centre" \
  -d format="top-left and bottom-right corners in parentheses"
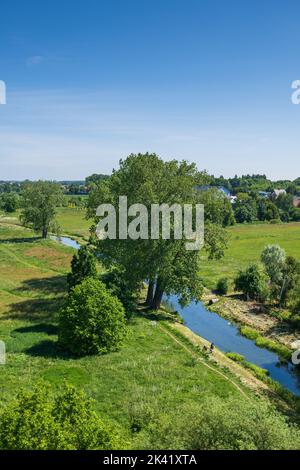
top-left (88, 154), bottom-right (225, 309)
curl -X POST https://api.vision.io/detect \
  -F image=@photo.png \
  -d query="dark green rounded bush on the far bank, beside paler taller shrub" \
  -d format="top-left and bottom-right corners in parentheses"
top-left (234, 264), bottom-right (268, 301)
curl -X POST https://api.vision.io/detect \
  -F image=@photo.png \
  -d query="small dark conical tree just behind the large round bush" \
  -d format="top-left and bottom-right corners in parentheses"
top-left (67, 245), bottom-right (97, 289)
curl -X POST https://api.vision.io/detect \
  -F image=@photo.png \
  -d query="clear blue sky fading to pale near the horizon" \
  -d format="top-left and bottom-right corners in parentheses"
top-left (0, 0), bottom-right (300, 180)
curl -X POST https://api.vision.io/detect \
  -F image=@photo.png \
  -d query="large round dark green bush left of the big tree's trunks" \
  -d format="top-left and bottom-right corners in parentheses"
top-left (59, 278), bottom-right (126, 355)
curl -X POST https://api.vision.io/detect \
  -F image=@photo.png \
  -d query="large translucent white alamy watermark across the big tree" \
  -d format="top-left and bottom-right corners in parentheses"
top-left (96, 196), bottom-right (204, 250)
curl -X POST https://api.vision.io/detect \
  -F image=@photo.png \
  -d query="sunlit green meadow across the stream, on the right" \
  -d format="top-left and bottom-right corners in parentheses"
top-left (201, 223), bottom-right (300, 289)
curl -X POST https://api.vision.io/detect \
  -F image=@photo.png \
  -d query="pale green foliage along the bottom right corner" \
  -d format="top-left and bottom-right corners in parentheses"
top-left (144, 397), bottom-right (300, 450)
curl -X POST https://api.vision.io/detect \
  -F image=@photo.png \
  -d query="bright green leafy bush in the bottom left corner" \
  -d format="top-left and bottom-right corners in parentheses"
top-left (0, 383), bottom-right (118, 450)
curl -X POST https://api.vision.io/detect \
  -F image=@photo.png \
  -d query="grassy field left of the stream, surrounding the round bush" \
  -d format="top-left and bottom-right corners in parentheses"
top-left (0, 224), bottom-right (270, 444)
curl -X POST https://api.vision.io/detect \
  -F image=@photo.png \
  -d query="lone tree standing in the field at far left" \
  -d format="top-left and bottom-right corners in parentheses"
top-left (20, 181), bottom-right (63, 238)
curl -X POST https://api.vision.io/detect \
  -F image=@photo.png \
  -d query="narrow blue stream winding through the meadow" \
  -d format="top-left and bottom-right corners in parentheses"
top-left (52, 237), bottom-right (300, 396)
